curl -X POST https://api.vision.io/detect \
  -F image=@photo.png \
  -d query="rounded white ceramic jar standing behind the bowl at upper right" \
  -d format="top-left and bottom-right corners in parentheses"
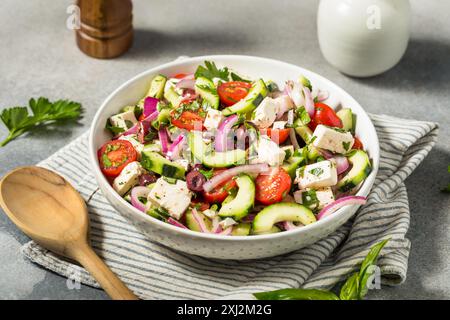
top-left (317, 0), bottom-right (411, 77)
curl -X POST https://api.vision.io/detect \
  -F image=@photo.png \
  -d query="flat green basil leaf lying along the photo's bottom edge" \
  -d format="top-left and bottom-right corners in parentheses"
top-left (253, 289), bottom-right (339, 300)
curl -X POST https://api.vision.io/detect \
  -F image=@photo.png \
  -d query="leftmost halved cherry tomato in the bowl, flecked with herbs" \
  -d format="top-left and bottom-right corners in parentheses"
top-left (98, 140), bottom-right (137, 177)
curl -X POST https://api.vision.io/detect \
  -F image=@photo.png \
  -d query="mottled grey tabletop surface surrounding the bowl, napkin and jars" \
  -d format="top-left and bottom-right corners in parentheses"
top-left (0, 0), bottom-right (450, 299)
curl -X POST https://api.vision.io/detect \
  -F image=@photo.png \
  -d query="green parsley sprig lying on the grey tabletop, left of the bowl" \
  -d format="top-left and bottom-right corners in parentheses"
top-left (0, 97), bottom-right (82, 147)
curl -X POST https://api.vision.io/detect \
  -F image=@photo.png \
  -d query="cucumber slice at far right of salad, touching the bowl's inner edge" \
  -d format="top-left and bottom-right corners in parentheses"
top-left (337, 150), bottom-right (372, 192)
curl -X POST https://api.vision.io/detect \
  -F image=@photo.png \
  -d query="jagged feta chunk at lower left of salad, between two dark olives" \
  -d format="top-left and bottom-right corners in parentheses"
top-left (148, 177), bottom-right (192, 220)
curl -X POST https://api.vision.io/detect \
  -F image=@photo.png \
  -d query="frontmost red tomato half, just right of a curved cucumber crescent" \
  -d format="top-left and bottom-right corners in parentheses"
top-left (255, 168), bottom-right (292, 205)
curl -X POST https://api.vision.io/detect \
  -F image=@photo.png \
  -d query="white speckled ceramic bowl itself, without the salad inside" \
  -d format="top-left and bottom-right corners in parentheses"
top-left (89, 55), bottom-right (379, 260)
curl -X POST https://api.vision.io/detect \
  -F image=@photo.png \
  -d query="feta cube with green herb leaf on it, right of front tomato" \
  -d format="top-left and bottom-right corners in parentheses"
top-left (295, 160), bottom-right (337, 189)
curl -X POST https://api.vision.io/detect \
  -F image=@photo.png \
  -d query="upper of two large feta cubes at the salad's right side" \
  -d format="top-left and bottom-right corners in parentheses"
top-left (313, 125), bottom-right (355, 154)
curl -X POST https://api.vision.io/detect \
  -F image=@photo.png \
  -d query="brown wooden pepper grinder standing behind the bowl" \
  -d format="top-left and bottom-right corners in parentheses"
top-left (76, 0), bottom-right (133, 59)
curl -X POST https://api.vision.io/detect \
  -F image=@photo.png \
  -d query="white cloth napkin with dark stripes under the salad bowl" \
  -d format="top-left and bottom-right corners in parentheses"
top-left (22, 115), bottom-right (438, 299)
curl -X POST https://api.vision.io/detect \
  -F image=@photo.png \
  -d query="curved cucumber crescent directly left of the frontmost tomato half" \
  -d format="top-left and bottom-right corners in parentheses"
top-left (219, 174), bottom-right (255, 221)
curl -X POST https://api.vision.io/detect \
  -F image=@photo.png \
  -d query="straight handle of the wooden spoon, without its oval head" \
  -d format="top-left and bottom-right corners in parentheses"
top-left (73, 244), bottom-right (139, 300)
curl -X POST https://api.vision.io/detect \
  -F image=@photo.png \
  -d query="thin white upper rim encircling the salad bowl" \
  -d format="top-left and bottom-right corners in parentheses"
top-left (88, 55), bottom-right (380, 241)
